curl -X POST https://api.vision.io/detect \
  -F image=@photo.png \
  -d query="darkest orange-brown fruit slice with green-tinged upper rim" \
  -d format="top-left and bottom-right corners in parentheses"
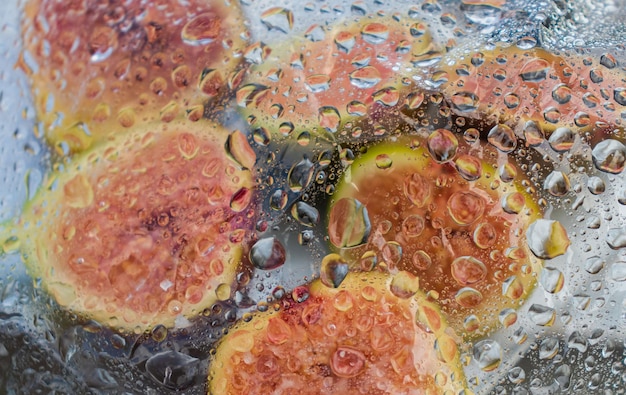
top-left (328, 137), bottom-right (541, 336)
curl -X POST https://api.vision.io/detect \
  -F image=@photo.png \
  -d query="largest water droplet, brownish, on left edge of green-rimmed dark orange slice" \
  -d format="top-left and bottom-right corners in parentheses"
top-left (328, 198), bottom-right (371, 248)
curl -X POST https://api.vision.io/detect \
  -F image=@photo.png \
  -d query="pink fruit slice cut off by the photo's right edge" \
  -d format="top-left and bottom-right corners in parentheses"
top-left (442, 47), bottom-right (626, 145)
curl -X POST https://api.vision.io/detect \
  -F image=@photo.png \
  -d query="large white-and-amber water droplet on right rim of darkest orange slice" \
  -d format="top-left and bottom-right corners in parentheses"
top-left (526, 219), bottom-right (570, 259)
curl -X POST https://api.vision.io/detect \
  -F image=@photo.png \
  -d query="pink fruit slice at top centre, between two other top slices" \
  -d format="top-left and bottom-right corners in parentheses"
top-left (237, 16), bottom-right (441, 142)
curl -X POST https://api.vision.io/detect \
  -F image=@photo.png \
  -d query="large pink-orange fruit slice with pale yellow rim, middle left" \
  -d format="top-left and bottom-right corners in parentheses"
top-left (15, 121), bottom-right (253, 330)
